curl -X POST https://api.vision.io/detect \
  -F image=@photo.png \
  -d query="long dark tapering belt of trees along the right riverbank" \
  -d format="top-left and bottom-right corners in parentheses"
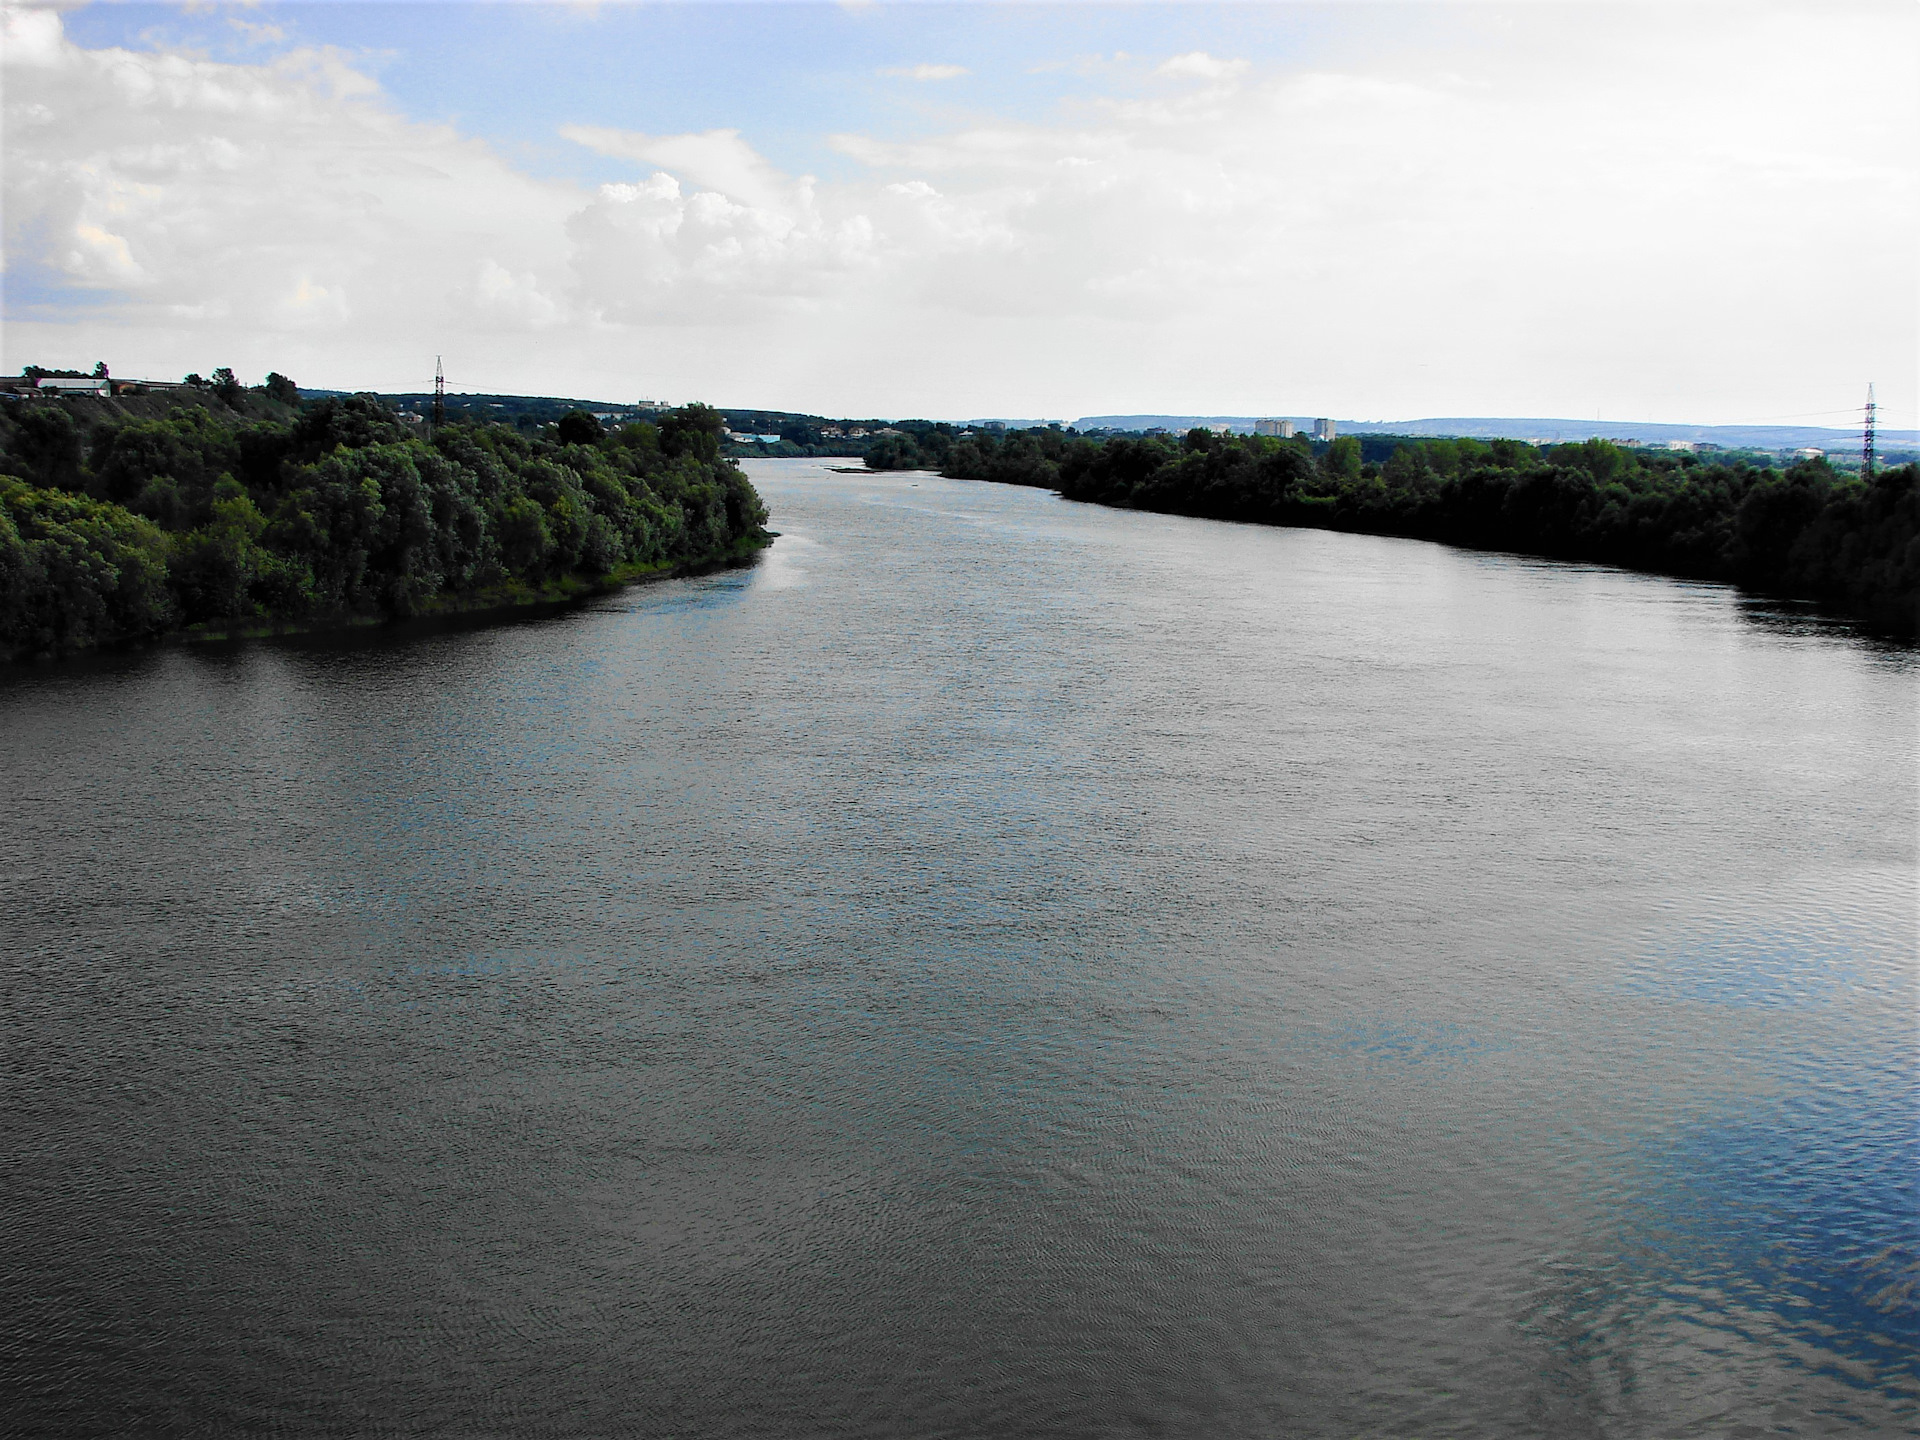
top-left (917, 430), bottom-right (1920, 636)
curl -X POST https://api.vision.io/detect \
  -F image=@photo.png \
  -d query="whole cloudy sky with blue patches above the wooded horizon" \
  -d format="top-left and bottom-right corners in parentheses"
top-left (0, 0), bottom-right (1920, 426)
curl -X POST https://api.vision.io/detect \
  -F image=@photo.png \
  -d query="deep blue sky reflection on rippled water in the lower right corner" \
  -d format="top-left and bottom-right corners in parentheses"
top-left (1524, 1104), bottom-right (1920, 1432)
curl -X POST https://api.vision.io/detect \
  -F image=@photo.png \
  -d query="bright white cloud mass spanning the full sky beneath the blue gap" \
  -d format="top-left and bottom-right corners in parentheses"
top-left (4, 6), bottom-right (1920, 424)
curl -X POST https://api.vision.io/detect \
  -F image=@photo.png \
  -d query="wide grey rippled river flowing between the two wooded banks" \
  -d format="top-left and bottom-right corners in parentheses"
top-left (0, 463), bottom-right (1920, 1436)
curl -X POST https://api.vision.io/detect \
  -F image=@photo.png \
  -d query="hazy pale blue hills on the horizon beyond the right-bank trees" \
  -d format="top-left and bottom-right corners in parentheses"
top-left (1073, 415), bottom-right (1920, 451)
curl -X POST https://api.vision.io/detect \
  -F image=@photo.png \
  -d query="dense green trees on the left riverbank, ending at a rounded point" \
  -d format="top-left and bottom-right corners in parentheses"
top-left (0, 376), bottom-right (766, 657)
